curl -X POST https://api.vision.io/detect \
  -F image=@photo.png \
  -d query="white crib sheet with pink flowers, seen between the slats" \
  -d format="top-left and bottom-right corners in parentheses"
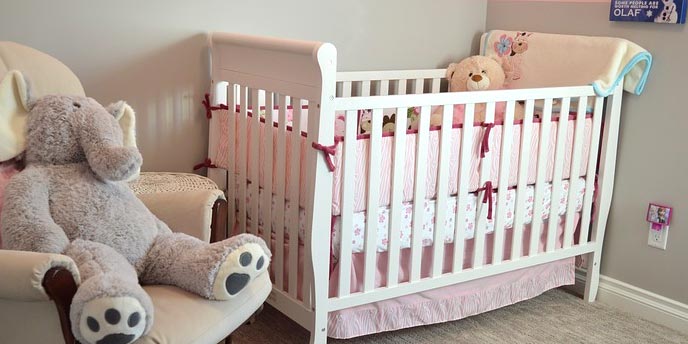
top-left (241, 178), bottom-right (585, 257)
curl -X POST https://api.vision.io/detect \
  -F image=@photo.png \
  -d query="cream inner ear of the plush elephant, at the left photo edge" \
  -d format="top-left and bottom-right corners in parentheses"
top-left (0, 70), bottom-right (31, 161)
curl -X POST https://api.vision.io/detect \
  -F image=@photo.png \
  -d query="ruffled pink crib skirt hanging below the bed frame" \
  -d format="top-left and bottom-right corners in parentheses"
top-left (254, 214), bottom-right (580, 338)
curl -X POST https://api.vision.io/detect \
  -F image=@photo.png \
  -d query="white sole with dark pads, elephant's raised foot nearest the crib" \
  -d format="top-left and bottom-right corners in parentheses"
top-left (213, 243), bottom-right (270, 300)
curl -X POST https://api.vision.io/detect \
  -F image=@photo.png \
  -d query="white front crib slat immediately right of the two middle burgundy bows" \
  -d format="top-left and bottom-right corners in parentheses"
top-left (492, 101), bottom-right (516, 264)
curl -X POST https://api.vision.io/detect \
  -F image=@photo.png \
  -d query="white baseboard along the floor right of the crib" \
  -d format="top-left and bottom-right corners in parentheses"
top-left (573, 269), bottom-right (688, 334)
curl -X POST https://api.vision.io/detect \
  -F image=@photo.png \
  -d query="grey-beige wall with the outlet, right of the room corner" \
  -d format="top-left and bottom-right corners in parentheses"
top-left (486, 2), bottom-right (688, 303)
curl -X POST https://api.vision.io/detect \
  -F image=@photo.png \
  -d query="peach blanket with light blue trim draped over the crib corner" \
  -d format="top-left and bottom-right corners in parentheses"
top-left (480, 30), bottom-right (652, 96)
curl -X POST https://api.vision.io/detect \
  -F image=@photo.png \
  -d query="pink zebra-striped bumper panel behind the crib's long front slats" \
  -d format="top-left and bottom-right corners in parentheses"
top-left (328, 119), bottom-right (592, 215)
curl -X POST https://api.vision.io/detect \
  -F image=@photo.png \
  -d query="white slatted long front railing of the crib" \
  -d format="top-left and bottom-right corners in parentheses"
top-left (328, 82), bottom-right (608, 311)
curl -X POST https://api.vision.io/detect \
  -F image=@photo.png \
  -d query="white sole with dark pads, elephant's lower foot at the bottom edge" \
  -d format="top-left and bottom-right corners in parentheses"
top-left (79, 297), bottom-right (146, 344)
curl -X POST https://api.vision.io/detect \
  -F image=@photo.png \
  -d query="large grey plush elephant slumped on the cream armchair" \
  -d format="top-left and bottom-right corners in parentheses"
top-left (0, 95), bottom-right (270, 343)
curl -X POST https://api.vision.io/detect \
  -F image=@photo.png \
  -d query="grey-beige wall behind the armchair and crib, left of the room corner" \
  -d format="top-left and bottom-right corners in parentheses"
top-left (0, 0), bottom-right (486, 171)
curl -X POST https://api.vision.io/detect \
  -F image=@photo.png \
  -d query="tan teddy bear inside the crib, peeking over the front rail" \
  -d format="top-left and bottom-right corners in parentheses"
top-left (430, 55), bottom-right (524, 125)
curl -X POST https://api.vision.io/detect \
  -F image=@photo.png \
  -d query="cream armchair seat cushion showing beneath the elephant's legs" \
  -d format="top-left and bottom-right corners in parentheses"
top-left (136, 274), bottom-right (272, 344)
